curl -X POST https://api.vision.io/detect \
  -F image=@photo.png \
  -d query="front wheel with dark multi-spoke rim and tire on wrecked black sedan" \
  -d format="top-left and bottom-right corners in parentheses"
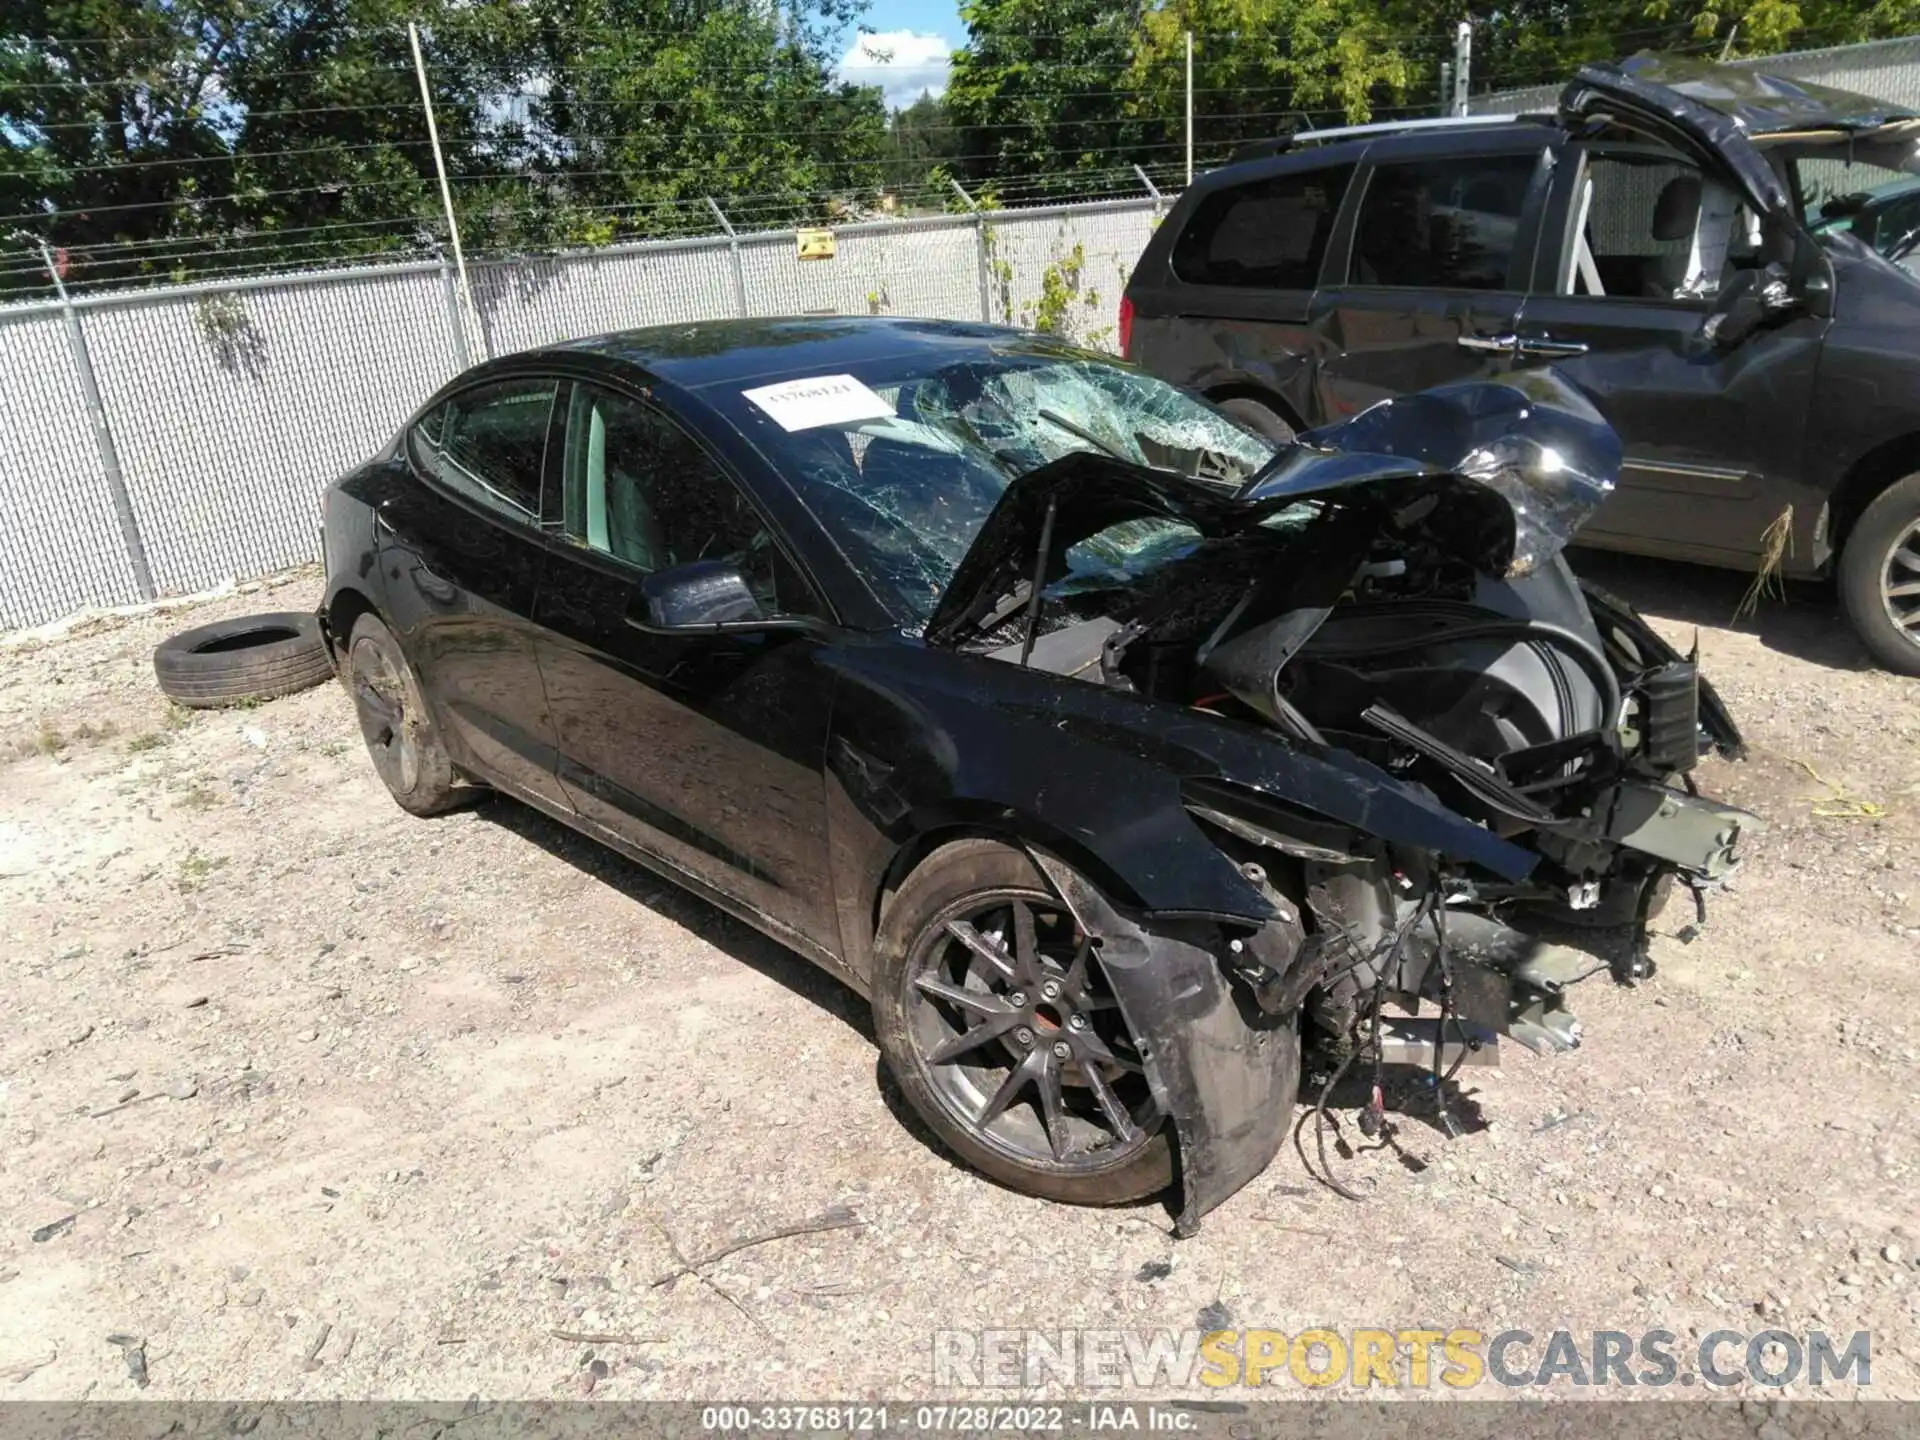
top-left (874, 839), bottom-right (1173, 1206)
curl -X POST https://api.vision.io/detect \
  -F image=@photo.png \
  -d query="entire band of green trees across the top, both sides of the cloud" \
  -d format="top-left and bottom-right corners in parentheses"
top-left (11, 0), bottom-right (1920, 290)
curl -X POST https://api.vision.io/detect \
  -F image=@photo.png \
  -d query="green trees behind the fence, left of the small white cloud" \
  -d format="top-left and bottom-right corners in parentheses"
top-left (0, 0), bottom-right (887, 288)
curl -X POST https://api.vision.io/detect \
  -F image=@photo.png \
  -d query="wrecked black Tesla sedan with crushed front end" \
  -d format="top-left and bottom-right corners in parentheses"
top-left (321, 319), bottom-right (1751, 1227)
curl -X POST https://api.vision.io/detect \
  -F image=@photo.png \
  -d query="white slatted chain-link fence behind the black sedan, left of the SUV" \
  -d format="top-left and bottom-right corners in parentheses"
top-left (0, 198), bottom-right (1160, 630)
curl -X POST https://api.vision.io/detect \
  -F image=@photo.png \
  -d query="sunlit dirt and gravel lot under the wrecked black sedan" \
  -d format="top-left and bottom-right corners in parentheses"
top-left (0, 559), bottom-right (1920, 1398)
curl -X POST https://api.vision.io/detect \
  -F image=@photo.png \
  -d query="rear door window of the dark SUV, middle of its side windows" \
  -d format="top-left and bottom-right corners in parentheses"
top-left (1348, 152), bottom-right (1540, 290)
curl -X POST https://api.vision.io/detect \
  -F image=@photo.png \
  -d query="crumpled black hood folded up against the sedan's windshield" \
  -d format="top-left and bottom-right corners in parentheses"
top-left (925, 371), bottom-right (1620, 645)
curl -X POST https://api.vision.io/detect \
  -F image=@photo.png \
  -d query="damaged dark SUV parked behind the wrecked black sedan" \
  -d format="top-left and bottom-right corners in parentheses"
top-left (1121, 56), bottom-right (1920, 676)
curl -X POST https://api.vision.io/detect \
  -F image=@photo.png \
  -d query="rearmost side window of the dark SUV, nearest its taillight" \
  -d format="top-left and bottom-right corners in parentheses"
top-left (1173, 165), bottom-right (1354, 290)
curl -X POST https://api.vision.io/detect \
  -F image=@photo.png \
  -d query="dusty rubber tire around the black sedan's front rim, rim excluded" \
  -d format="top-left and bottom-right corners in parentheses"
top-left (872, 839), bottom-right (1173, 1206)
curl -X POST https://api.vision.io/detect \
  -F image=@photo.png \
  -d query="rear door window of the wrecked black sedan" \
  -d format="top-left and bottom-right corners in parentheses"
top-left (413, 380), bottom-right (555, 520)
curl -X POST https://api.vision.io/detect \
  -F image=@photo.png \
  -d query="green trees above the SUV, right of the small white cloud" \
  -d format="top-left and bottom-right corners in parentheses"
top-left (947, 0), bottom-right (1920, 194)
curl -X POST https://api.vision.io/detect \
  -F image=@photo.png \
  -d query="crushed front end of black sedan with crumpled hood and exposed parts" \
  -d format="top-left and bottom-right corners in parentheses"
top-left (925, 372), bottom-right (1759, 1121)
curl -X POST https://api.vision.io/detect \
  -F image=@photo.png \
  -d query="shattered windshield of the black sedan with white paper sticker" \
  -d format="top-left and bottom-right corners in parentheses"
top-left (707, 351), bottom-right (1275, 626)
